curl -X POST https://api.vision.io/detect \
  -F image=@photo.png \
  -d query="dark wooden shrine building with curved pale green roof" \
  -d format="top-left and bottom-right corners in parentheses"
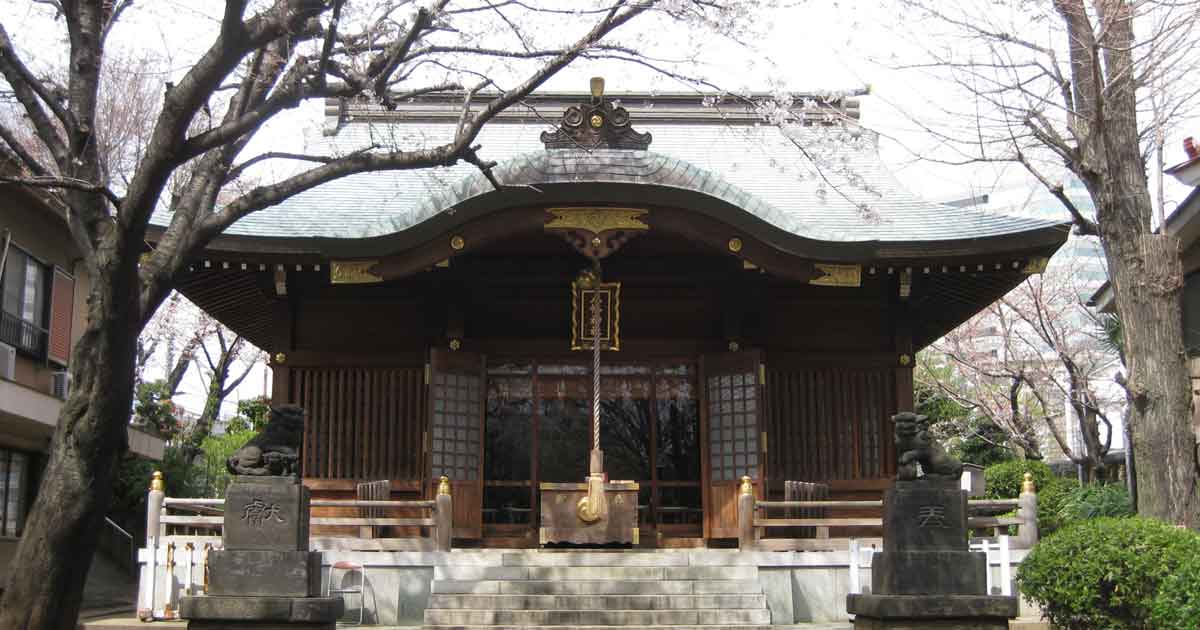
top-left (151, 87), bottom-right (1069, 547)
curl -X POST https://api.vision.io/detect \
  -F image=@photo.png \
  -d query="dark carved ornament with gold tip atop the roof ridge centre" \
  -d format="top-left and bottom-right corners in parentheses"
top-left (541, 77), bottom-right (652, 151)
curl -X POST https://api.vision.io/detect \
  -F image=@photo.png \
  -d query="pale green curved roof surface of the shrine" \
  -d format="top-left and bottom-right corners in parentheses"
top-left (164, 91), bottom-right (1061, 253)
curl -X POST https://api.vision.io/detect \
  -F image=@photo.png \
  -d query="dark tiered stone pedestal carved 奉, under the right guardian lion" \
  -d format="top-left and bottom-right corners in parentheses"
top-left (846, 479), bottom-right (1018, 630)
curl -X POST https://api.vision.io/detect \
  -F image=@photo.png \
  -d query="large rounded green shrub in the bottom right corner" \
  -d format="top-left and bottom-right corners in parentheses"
top-left (1016, 517), bottom-right (1200, 630)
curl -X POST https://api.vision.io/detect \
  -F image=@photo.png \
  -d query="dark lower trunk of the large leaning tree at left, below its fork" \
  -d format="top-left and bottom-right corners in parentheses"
top-left (0, 258), bottom-right (139, 630)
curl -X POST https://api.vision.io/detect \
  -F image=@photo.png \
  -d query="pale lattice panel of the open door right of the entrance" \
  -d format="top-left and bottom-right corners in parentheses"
top-left (708, 371), bottom-right (758, 481)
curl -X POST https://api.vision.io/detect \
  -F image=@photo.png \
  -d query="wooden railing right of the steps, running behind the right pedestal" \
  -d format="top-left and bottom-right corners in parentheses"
top-left (738, 475), bottom-right (1038, 551)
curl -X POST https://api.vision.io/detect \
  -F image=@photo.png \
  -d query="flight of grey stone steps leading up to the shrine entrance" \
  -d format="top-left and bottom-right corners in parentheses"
top-left (425, 551), bottom-right (770, 630)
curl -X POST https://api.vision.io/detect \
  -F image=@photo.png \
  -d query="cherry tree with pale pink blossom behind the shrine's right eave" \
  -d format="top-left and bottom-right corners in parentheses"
top-left (917, 257), bottom-right (1124, 479)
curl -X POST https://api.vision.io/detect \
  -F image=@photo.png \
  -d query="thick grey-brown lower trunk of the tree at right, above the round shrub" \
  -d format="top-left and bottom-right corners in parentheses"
top-left (1105, 228), bottom-right (1200, 528)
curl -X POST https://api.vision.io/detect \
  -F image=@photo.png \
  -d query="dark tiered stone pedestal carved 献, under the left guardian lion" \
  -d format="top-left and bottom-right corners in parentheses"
top-left (179, 476), bottom-right (342, 630)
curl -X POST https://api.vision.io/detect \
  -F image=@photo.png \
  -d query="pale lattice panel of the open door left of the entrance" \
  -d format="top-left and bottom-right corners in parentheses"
top-left (430, 373), bottom-right (484, 481)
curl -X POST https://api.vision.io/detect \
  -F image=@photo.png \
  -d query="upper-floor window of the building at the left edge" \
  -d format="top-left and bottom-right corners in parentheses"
top-left (0, 247), bottom-right (50, 359)
